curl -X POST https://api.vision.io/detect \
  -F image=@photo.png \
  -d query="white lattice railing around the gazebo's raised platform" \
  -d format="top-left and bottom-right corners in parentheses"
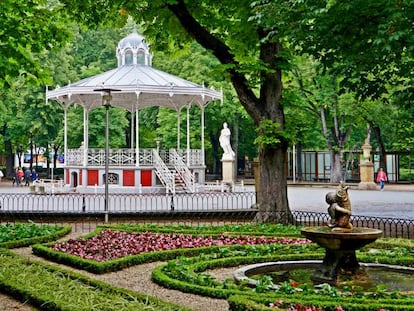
top-left (65, 148), bottom-right (204, 166)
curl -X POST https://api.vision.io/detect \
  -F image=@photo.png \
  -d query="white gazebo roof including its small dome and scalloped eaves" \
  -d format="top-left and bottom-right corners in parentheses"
top-left (46, 32), bottom-right (222, 111)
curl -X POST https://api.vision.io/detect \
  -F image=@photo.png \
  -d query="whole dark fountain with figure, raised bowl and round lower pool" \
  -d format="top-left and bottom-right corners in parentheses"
top-left (234, 183), bottom-right (414, 291)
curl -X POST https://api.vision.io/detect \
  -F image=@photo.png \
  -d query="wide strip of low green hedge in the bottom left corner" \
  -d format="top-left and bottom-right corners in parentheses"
top-left (0, 249), bottom-right (191, 311)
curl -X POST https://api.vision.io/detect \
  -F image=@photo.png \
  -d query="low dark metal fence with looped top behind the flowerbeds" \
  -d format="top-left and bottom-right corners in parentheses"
top-left (0, 192), bottom-right (414, 239)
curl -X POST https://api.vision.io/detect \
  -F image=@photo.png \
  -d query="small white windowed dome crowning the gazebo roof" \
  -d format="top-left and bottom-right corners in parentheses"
top-left (116, 29), bottom-right (152, 67)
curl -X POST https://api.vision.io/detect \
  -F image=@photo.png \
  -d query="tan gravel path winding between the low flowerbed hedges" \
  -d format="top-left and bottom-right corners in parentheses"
top-left (6, 233), bottom-right (231, 311)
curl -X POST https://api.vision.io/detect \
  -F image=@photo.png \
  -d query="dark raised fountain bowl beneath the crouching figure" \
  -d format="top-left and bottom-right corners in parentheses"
top-left (301, 227), bottom-right (382, 250)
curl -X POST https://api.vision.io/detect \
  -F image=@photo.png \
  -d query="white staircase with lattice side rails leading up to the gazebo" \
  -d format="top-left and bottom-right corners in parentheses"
top-left (152, 149), bottom-right (195, 194)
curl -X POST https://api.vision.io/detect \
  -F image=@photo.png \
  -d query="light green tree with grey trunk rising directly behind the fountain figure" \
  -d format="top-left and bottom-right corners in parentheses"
top-left (292, 55), bottom-right (362, 183)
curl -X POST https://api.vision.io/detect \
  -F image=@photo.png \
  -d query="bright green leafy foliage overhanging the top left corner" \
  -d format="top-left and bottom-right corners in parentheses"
top-left (0, 0), bottom-right (70, 86)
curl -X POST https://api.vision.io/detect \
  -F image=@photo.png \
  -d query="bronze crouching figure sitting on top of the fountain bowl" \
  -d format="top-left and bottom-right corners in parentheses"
top-left (325, 182), bottom-right (352, 232)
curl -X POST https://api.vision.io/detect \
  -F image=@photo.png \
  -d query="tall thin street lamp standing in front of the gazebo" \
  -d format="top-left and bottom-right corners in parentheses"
top-left (94, 88), bottom-right (120, 223)
